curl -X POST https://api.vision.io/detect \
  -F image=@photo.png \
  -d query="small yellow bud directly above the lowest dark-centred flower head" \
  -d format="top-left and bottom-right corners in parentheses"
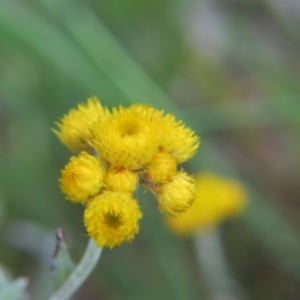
top-left (105, 168), bottom-right (138, 194)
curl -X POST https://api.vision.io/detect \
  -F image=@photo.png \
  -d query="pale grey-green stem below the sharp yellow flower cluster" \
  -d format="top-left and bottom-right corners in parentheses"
top-left (49, 239), bottom-right (103, 300)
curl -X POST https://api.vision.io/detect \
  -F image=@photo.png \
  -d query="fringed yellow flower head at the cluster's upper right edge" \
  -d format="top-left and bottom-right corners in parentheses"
top-left (158, 114), bottom-right (200, 163)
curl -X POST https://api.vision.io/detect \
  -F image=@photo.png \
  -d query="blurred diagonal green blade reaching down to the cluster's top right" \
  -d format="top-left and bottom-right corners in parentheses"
top-left (62, 4), bottom-right (175, 111)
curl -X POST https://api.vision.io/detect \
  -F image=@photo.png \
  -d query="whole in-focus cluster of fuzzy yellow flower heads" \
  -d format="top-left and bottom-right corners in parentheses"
top-left (53, 97), bottom-right (199, 248)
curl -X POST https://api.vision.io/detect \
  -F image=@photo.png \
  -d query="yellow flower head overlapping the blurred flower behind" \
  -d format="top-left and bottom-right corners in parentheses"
top-left (156, 171), bottom-right (195, 215)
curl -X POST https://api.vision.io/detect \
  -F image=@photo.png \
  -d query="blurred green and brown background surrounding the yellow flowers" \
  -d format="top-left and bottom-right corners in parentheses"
top-left (0, 0), bottom-right (300, 300)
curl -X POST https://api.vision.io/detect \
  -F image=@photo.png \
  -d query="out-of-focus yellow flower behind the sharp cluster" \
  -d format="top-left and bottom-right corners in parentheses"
top-left (167, 173), bottom-right (247, 234)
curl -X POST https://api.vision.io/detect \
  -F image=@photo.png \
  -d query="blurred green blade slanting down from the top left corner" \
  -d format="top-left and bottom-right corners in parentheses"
top-left (0, 2), bottom-right (120, 100)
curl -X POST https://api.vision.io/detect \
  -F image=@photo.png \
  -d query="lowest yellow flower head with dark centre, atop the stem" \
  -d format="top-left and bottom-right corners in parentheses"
top-left (84, 191), bottom-right (142, 248)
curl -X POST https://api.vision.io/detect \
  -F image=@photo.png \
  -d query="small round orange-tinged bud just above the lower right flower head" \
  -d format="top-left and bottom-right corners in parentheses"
top-left (146, 152), bottom-right (177, 183)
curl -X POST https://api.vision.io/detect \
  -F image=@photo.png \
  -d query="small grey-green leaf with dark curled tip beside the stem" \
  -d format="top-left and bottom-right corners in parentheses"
top-left (51, 228), bottom-right (75, 291)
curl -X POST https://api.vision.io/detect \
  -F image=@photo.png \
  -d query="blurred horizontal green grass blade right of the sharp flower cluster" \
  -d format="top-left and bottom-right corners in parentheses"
top-left (185, 98), bottom-right (300, 133)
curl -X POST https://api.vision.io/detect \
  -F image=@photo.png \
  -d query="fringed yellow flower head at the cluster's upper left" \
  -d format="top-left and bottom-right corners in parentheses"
top-left (53, 97), bottom-right (105, 151)
